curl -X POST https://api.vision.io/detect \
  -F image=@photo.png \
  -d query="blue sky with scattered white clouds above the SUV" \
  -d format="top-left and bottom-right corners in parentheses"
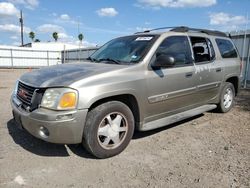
top-left (0, 0), bottom-right (250, 46)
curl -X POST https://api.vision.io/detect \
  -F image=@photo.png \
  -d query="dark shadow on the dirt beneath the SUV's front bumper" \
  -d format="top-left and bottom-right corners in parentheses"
top-left (7, 119), bottom-right (94, 158)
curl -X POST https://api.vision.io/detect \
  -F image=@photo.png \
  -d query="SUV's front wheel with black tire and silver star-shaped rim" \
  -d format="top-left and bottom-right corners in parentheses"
top-left (83, 101), bottom-right (135, 158)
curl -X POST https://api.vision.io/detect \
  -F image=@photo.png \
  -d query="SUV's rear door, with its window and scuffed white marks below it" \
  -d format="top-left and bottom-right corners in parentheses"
top-left (190, 36), bottom-right (224, 104)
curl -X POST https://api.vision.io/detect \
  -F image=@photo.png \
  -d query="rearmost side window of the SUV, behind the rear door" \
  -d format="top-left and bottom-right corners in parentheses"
top-left (215, 39), bottom-right (237, 58)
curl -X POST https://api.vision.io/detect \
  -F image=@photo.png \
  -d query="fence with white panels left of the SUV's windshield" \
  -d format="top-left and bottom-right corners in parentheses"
top-left (0, 47), bottom-right (98, 68)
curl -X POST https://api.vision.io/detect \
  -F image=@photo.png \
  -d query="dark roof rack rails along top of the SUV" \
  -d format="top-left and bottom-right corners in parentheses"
top-left (136, 26), bottom-right (227, 37)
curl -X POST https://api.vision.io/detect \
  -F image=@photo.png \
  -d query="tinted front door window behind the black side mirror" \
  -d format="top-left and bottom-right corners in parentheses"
top-left (156, 36), bottom-right (192, 66)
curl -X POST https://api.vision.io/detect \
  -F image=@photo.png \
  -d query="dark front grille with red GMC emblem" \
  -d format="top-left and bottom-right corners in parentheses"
top-left (17, 82), bottom-right (36, 106)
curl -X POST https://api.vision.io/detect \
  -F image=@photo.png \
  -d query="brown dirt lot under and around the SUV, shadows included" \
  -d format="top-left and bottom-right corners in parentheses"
top-left (0, 70), bottom-right (250, 188)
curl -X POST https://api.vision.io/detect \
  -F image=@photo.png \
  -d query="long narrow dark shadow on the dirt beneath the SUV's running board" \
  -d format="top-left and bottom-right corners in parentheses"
top-left (132, 114), bottom-right (204, 139)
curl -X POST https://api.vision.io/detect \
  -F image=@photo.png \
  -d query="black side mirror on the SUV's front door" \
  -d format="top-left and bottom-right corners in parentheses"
top-left (152, 53), bottom-right (175, 68)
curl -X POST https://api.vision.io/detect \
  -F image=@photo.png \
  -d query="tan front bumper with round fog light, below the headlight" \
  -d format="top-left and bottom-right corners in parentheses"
top-left (11, 95), bottom-right (88, 144)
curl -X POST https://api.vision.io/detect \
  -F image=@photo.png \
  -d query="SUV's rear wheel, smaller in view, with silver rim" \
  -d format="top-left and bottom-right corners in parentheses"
top-left (217, 82), bottom-right (235, 113)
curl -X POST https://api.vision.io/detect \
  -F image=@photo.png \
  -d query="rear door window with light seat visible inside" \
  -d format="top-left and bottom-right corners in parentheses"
top-left (190, 37), bottom-right (215, 63)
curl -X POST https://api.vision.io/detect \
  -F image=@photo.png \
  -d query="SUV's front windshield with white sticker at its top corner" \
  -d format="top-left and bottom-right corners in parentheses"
top-left (89, 35), bottom-right (156, 64)
